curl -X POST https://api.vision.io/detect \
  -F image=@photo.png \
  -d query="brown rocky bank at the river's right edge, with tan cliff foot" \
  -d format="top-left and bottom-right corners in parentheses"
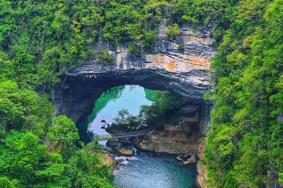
top-left (138, 131), bottom-right (208, 188)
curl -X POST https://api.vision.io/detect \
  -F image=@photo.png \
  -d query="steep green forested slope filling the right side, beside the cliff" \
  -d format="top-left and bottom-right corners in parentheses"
top-left (206, 0), bottom-right (283, 187)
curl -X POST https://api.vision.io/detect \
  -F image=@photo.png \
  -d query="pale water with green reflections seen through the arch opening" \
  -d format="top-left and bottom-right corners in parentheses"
top-left (78, 85), bottom-right (155, 146)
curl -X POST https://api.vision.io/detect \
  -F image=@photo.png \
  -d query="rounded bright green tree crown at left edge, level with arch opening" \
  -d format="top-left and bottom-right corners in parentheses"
top-left (0, 81), bottom-right (52, 137)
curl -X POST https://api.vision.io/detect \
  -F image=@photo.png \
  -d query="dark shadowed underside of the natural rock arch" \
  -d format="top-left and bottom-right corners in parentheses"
top-left (53, 64), bottom-right (211, 135)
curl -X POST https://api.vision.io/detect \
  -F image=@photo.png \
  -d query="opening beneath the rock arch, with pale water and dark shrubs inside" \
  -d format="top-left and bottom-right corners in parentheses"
top-left (78, 85), bottom-right (195, 145)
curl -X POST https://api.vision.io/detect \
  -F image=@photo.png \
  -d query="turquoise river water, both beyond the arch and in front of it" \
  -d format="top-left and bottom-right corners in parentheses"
top-left (79, 85), bottom-right (196, 188)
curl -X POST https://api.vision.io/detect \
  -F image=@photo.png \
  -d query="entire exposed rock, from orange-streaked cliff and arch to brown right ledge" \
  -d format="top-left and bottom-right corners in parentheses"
top-left (52, 20), bottom-right (215, 187)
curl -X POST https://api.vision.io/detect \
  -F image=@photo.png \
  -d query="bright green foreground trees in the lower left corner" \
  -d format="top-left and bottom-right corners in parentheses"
top-left (0, 89), bottom-right (115, 188)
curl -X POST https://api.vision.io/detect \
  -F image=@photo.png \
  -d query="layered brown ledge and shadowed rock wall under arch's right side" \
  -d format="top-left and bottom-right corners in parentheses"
top-left (138, 101), bottom-right (210, 157)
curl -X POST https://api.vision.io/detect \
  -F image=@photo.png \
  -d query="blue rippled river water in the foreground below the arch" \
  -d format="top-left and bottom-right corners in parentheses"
top-left (114, 152), bottom-right (196, 188)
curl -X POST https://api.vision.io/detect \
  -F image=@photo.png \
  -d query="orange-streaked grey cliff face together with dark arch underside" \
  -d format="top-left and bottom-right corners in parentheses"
top-left (55, 22), bottom-right (215, 125)
